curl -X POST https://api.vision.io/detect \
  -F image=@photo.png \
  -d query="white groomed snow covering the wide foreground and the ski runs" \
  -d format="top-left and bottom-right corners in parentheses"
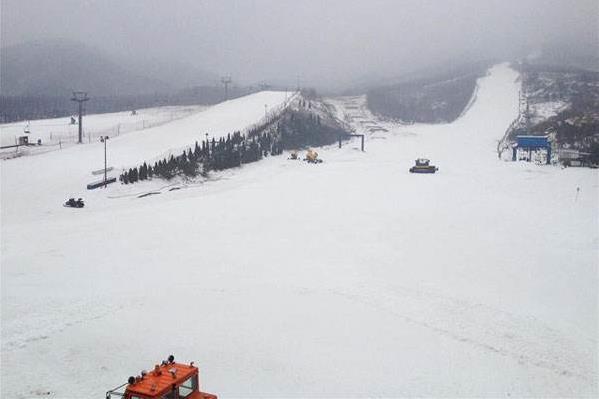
top-left (1, 65), bottom-right (599, 398)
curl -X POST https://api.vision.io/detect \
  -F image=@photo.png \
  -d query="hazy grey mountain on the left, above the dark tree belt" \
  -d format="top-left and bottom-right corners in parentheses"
top-left (0, 40), bottom-right (213, 96)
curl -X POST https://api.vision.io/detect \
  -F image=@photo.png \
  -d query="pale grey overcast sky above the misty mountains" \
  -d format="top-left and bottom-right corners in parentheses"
top-left (0, 0), bottom-right (599, 88)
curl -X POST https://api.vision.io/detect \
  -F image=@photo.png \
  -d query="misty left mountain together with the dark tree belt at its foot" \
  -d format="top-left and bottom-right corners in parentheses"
top-left (0, 40), bottom-right (257, 122)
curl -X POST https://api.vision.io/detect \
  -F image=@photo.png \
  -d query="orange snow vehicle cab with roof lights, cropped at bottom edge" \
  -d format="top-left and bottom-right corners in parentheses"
top-left (106, 355), bottom-right (217, 399)
